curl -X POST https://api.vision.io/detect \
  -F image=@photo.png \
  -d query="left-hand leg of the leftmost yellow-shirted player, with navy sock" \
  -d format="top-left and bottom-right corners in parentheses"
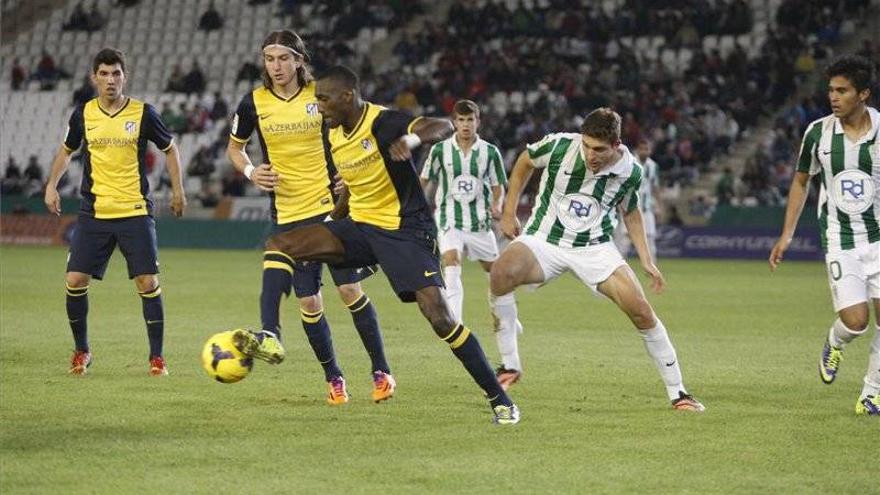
top-left (64, 216), bottom-right (116, 375)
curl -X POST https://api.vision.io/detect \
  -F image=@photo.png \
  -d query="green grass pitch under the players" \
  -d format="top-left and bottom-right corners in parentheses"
top-left (0, 247), bottom-right (880, 494)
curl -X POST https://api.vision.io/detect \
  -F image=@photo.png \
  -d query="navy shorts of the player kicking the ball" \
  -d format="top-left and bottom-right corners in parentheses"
top-left (325, 218), bottom-right (445, 302)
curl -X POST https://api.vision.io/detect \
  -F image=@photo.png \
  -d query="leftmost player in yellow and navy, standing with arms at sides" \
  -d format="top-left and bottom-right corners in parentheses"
top-left (45, 48), bottom-right (186, 376)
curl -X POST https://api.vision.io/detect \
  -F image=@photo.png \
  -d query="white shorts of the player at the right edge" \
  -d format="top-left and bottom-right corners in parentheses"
top-left (825, 242), bottom-right (880, 311)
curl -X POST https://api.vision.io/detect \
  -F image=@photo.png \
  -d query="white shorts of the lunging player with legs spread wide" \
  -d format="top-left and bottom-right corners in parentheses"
top-left (513, 235), bottom-right (626, 292)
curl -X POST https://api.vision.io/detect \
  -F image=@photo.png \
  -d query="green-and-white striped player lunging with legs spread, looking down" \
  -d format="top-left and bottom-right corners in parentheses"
top-left (491, 108), bottom-right (705, 412)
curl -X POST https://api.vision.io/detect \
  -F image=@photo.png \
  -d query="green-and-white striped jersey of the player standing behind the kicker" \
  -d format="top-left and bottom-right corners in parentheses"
top-left (422, 135), bottom-right (507, 232)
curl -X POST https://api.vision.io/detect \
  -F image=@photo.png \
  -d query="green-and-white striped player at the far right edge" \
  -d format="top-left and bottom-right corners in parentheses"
top-left (770, 56), bottom-right (880, 416)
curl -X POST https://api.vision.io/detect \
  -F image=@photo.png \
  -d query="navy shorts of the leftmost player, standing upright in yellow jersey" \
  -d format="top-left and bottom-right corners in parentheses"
top-left (67, 215), bottom-right (159, 280)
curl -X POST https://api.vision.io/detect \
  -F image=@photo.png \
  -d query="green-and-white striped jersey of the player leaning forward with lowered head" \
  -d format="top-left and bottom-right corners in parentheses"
top-left (524, 133), bottom-right (642, 247)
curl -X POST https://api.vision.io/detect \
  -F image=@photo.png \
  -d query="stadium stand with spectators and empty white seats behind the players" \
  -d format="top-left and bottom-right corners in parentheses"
top-left (0, 0), bottom-right (871, 225)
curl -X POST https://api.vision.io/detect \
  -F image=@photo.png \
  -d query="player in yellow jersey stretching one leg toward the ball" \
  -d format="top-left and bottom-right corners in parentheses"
top-left (245, 66), bottom-right (519, 424)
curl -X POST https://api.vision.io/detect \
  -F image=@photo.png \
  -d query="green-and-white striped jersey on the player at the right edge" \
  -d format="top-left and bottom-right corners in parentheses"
top-left (797, 107), bottom-right (880, 252)
